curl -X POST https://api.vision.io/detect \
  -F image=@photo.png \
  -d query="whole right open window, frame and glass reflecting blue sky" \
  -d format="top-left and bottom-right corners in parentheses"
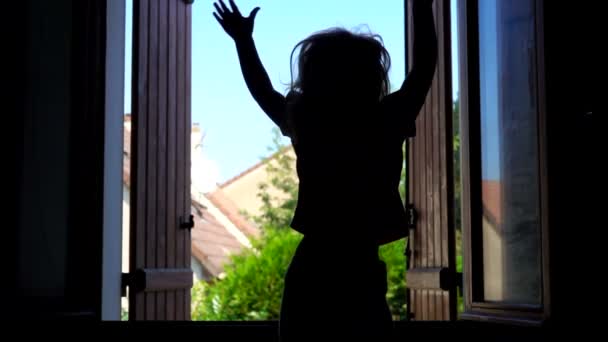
top-left (459, 0), bottom-right (547, 321)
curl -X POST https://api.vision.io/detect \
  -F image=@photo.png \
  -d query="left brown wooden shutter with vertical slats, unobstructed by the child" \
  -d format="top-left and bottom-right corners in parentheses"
top-left (129, 0), bottom-right (192, 320)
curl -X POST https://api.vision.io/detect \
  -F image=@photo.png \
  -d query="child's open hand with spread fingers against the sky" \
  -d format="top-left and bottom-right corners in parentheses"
top-left (213, 0), bottom-right (260, 41)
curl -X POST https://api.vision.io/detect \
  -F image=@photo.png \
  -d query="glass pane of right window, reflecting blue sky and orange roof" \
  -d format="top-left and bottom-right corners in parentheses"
top-left (479, 0), bottom-right (541, 304)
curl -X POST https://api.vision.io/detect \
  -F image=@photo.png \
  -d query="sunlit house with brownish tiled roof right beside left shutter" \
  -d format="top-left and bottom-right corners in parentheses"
top-left (122, 114), bottom-right (259, 305)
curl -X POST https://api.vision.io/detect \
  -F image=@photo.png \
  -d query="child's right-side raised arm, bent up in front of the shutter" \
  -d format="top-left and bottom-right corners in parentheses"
top-left (382, 0), bottom-right (437, 139)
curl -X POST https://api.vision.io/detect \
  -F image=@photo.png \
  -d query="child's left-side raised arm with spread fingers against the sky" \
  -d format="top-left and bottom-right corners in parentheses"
top-left (213, 0), bottom-right (285, 127)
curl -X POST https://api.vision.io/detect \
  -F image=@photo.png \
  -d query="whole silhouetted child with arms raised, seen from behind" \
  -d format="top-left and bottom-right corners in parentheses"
top-left (213, 0), bottom-right (437, 341)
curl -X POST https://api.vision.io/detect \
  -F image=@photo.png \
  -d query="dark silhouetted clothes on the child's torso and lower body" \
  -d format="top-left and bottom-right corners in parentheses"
top-left (279, 96), bottom-right (414, 341)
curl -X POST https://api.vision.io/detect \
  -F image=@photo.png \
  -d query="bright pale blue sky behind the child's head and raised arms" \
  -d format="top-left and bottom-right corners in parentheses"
top-left (125, 0), bottom-right (470, 182)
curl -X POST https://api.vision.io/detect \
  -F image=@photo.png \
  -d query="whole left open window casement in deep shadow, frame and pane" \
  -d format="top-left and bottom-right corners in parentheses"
top-left (8, 0), bottom-right (106, 318)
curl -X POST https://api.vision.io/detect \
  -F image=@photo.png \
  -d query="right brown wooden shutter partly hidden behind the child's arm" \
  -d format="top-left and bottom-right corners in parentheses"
top-left (407, 0), bottom-right (456, 321)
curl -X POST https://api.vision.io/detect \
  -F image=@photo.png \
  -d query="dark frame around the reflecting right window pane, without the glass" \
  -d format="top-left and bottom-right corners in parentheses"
top-left (458, 0), bottom-right (550, 325)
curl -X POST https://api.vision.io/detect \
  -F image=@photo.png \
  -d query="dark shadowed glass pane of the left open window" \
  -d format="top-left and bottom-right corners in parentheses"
top-left (17, 0), bottom-right (72, 305)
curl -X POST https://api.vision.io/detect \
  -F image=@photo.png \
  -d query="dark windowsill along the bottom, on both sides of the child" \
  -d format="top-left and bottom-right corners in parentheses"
top-left (20, 319), bottom-right (550, 342)
